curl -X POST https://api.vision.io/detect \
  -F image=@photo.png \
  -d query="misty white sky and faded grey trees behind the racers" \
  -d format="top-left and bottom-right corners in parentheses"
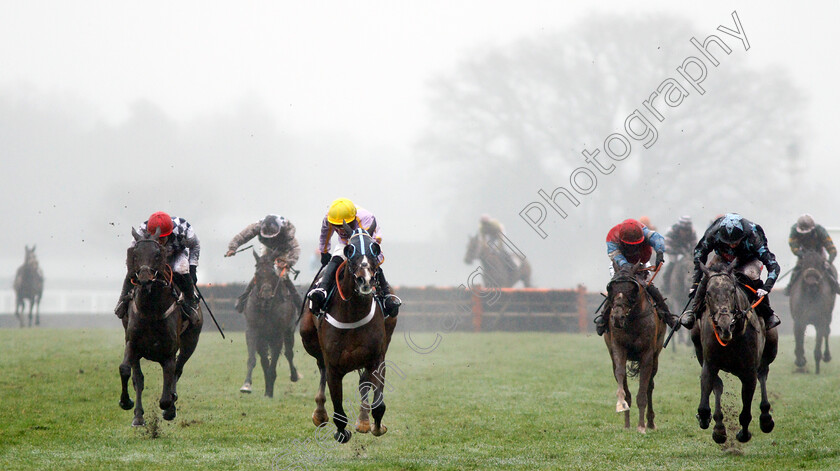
top-left (0, 1), bottom-right (840, 318)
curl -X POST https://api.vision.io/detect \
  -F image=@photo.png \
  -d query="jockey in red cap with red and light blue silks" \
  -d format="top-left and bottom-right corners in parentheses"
top-left (595, 219), bottom-right (679, 335)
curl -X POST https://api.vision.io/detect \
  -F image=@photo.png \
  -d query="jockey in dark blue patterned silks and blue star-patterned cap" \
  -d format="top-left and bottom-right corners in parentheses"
top-left (680, 213), bottom-right (781, 330)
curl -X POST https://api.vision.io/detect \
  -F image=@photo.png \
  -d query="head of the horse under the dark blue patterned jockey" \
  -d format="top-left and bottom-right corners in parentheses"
top-left (700, 260), bottom-right (745, 343)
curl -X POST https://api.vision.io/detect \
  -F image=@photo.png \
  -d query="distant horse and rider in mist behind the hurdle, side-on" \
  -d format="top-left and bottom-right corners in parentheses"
top-left (464, 215), bottom-right (531, 288)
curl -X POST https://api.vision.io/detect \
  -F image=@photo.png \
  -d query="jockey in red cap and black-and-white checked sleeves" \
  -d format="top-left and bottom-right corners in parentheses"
top-left (114, 211), bottom-right (201, 324)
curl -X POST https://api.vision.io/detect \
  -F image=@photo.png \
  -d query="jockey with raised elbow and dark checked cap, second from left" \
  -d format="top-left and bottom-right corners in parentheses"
top-left (225, 214), bottom-right (303, 312)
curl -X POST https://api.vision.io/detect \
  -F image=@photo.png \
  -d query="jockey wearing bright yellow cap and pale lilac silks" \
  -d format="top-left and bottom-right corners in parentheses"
top-left (306, 198), bottom-right (402, 317)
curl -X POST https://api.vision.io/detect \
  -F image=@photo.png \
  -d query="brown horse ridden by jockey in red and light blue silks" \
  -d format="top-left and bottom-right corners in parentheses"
top-left (604, 264), bottom-right (666, 433)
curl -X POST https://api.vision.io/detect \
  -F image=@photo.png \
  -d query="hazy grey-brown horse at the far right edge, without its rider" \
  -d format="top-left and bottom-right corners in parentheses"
top-left (790, 250), bottom-right (834, 374)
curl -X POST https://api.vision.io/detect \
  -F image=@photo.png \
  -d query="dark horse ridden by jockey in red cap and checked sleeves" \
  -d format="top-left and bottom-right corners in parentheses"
top-left (120, 228), bottom-right (203, 427)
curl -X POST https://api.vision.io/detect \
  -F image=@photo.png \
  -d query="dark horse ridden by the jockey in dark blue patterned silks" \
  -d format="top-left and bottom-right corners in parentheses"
top-left (691, 260), bottom-right (779, 443)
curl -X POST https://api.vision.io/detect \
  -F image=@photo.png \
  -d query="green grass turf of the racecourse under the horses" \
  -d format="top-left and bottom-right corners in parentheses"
top-left (0, 329), bottom-right (840, 471)
